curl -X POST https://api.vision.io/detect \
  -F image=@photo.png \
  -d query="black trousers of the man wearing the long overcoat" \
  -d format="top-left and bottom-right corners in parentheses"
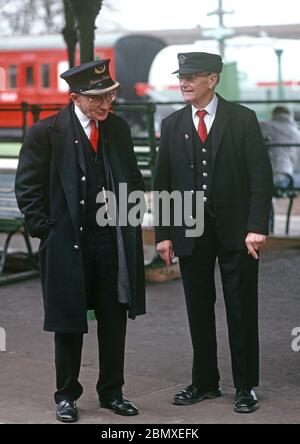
top-left (54, 228), bottom-right (128, 403)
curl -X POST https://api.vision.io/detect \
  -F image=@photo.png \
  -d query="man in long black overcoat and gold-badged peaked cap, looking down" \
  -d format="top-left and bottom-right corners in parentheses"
top-left (16, 59), bottom-right (145, 422)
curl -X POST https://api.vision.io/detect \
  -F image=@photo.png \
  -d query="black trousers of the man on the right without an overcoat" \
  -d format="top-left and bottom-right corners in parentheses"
top-left (179, 214), bottom-right (259, 390)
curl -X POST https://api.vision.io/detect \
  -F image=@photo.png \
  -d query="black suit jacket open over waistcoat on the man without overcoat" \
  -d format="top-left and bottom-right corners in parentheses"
top-left (154, 97), bottom-right (273, 256)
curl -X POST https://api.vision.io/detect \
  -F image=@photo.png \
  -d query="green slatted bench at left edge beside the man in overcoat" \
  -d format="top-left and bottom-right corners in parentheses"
top-left (0, 168), bottom-right (34, 275)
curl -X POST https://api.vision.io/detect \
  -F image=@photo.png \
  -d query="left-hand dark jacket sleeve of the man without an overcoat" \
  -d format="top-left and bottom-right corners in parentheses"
top-left (154, 121), bottom-right (172, 243)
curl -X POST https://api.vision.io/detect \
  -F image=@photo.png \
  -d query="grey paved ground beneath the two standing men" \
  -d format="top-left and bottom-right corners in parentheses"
top-left (0, 249), bottom-right (300, 424)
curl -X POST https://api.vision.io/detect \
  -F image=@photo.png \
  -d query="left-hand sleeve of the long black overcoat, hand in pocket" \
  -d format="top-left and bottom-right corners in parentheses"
top-left (15, 123), bottom-right (50, 238)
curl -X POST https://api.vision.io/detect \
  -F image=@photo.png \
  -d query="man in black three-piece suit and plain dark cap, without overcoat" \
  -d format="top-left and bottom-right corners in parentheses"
top-left (154, 52), bottom-right (272, 413)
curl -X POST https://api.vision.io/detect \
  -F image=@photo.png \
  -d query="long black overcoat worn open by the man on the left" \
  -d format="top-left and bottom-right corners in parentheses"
top-left (16, 104), bottom-right (145, 332)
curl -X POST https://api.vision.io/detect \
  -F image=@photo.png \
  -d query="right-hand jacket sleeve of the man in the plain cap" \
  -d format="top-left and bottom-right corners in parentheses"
top-left (245, 112), bottom-right (273, 235)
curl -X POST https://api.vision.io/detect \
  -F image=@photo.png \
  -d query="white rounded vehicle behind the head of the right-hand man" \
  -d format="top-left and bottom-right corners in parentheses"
top-left (147, 37), bottom-right (300, 126)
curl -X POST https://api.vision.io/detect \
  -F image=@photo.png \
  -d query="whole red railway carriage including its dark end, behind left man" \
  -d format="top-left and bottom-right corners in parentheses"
top-left (0, 33), bottom-right (165, 130)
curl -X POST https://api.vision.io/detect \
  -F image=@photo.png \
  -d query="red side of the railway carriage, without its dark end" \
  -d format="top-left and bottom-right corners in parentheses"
top-left (0, 35), bottom-right (115, 128)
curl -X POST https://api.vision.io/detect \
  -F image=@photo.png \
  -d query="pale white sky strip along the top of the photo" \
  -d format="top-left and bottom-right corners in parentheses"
top-left (99, 0), bottom-right (300, 30)
